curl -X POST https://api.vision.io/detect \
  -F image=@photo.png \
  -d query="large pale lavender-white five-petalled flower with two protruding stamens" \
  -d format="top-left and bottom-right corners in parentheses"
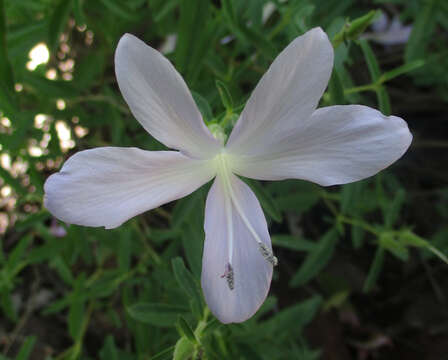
top-left (45, 28), bottom-right (412, 323)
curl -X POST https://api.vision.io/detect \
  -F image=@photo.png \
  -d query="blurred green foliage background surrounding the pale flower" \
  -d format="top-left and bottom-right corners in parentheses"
top-left (0, 0), bottom-right (448, 360)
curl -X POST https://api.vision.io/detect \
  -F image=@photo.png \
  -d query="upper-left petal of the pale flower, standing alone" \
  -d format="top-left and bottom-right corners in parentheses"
top-left (115, 34), bottom-right (220, 158)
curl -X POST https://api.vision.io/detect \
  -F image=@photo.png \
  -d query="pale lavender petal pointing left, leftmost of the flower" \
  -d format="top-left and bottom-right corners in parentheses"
top-left (44, 147), bottom-right (214, 229)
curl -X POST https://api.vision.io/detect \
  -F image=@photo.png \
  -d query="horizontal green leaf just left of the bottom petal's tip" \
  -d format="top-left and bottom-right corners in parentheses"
top-left (127, 303), bottom-right (188, 327)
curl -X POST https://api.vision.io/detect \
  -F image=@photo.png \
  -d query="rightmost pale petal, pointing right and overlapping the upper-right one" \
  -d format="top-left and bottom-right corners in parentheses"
top-left (234, 105), bottom-right (412, 186)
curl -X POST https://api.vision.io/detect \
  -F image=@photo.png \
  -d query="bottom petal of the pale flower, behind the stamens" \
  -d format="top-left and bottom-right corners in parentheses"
top-left (201, 175), bottom-right (272, 323)
